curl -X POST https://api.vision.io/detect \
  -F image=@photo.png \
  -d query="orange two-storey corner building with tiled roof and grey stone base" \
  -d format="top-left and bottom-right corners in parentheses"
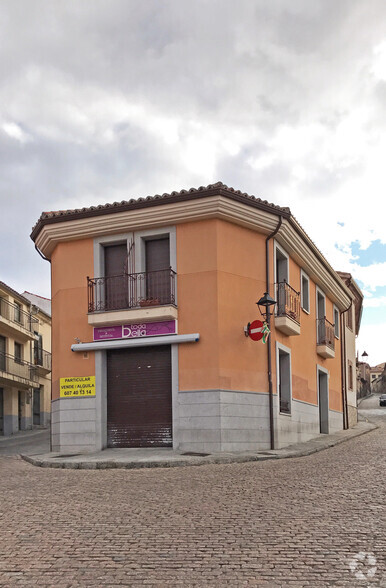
top-left (31, 183), bottom-right (355, 452)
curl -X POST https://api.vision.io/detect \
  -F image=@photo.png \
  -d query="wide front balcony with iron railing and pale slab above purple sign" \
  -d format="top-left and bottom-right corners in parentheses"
top-left (87, 268), bottom-right (177, 326)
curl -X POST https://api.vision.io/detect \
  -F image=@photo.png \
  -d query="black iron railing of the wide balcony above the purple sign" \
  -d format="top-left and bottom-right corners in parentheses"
top-left (87, 268), bottom-right (176, 312)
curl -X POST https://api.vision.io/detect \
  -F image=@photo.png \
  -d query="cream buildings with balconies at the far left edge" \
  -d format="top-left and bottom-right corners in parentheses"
top-left (0, 282), bottom-right (51, 435)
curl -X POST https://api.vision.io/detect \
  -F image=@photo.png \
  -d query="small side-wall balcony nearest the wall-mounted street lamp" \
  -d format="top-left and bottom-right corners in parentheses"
top-left (275, 282), bottom-right (300, 335)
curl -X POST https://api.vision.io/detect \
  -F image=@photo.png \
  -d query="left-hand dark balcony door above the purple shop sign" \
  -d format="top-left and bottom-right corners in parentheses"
top-left (104, 243), bottom-right (128, 310)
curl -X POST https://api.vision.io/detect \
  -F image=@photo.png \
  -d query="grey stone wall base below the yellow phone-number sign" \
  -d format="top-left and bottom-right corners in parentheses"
top-left (51, 397), bottom-right (99, 453)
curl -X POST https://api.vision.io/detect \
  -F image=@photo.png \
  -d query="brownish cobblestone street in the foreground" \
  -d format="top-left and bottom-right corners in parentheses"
top-left (0, 398), bottom-right (386, 588)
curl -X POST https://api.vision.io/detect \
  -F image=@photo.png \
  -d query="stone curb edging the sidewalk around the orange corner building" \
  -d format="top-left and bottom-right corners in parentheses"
top-left (20, 423), bottom-right (379, 470)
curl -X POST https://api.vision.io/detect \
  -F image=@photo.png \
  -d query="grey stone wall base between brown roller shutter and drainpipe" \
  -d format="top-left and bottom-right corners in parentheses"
top-left (174, 390), bottom-right (270, 453)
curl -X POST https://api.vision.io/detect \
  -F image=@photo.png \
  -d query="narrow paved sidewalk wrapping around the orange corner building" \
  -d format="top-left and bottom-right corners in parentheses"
top-left (21, 421), bottom-right (378, 470)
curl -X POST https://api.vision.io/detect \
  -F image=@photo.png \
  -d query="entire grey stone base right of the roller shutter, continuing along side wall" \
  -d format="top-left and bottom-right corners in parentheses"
top-left (178, 390), bottom-right (343, 453)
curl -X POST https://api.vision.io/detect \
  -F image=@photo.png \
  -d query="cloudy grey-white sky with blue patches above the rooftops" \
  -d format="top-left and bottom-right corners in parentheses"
top-left (0, 0), bottom-right (386, 364)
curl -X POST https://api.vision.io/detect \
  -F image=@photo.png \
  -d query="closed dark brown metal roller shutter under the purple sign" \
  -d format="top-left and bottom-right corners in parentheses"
top-left (107, 345), bottom-right (172, 447)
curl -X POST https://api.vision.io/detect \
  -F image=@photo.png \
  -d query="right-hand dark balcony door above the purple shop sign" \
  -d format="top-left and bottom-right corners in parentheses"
top-left (145, 237), bottom-right (170, 304)
